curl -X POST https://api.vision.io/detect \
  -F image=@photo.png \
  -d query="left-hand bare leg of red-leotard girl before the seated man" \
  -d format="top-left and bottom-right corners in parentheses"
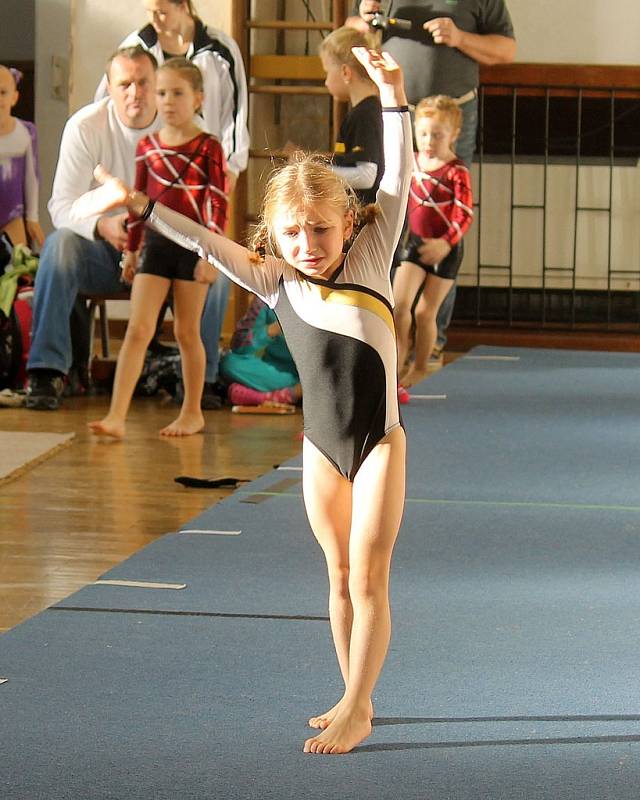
top-left (89, 273), bottom-right (170, 439)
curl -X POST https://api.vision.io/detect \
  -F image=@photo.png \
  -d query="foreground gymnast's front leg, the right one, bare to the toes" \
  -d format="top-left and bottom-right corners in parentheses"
top-left (304, 428), bottom-right (406, 754)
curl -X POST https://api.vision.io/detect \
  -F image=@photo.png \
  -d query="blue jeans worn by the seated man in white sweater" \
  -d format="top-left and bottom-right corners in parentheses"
top-left (27, 228), bottom-right (229, 382)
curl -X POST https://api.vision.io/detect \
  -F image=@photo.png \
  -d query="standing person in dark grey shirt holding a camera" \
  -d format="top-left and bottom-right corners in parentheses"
top-left (347, 0), bottom-right (516, 364)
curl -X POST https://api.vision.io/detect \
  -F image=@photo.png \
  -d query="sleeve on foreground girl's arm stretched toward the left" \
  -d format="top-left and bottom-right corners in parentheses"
top-left (147, 203), bottom-right (285, 308)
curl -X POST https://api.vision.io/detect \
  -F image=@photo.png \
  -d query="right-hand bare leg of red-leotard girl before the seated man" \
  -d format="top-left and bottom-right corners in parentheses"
top-left (160, 280), bottom-right (208, 436)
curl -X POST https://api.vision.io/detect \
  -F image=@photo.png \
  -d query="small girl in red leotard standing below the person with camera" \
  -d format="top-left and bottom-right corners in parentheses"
top-left (393, 95), bottom-right (473, 397)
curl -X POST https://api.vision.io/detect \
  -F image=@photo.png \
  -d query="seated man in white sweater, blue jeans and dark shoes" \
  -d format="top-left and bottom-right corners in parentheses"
top-left (25, 46), bottom-right (228, 410)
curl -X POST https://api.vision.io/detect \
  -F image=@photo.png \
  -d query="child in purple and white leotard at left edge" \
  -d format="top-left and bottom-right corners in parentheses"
top-left (0, 65), bottom-right (44, 247)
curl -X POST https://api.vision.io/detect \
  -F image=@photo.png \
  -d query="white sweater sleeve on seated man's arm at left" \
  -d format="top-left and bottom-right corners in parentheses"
top-left (47, 117), bottom-right (101, 239)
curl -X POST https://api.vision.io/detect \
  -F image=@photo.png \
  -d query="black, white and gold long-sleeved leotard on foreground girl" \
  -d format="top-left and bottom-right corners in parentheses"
top-left (149, 110), bottom-right (413, 480)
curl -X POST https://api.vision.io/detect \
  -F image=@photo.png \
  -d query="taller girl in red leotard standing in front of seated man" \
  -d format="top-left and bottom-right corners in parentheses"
top-left (89, 58), bottom-right (227, 438)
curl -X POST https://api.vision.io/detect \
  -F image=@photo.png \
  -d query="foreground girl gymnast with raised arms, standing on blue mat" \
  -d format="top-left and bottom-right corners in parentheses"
top-left (75, 49), bottom-right (411, 754)
